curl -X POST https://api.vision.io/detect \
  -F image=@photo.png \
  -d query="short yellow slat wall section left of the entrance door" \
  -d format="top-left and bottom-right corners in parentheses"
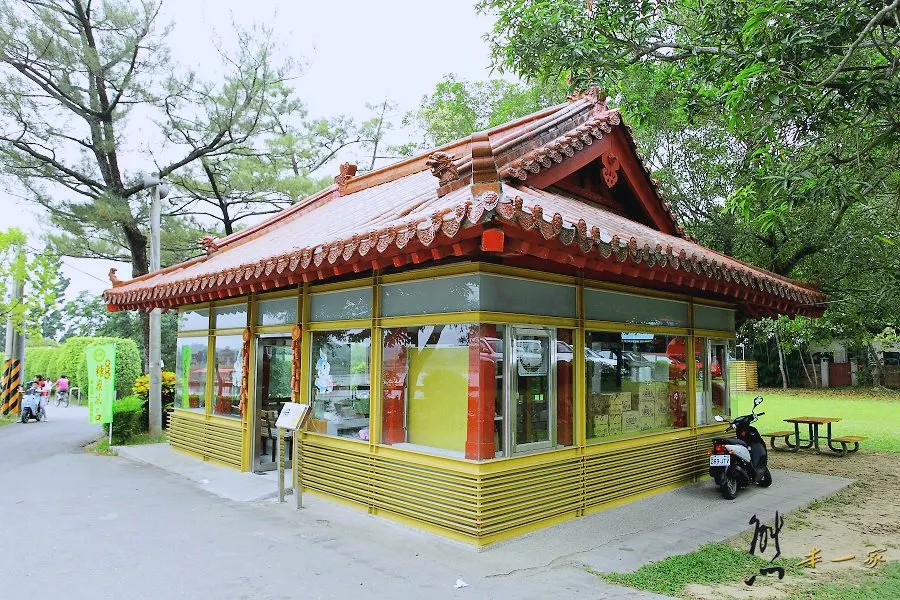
top-left (168, 411), bottom-right (242, 469)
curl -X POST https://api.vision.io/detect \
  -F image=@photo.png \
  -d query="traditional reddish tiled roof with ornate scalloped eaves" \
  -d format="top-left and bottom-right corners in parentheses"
top-left (104, 96), bottom-right (824, 314)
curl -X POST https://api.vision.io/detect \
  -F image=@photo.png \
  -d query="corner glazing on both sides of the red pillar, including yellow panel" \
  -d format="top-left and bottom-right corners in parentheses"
top-left (382, 323), bottom-right (576, 460)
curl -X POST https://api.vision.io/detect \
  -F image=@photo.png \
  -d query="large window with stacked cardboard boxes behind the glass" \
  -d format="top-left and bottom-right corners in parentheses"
top-left (585, 332), bottom-right (688, 442)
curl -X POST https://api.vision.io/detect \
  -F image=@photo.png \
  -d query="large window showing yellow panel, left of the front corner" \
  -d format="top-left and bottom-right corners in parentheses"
top-left (382, 324), bottom-right (486, 458)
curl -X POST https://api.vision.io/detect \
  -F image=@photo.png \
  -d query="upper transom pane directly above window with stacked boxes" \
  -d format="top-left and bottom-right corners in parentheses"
top-left (584, 288), bottom-right (688, 327)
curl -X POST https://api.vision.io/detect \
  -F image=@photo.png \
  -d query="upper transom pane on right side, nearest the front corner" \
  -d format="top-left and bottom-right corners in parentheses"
top-left (479, 274), bottom-right (576, 317)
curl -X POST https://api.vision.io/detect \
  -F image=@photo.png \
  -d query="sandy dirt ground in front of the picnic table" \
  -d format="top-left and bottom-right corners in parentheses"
top-left (686, 451), bottom-right (900, 600)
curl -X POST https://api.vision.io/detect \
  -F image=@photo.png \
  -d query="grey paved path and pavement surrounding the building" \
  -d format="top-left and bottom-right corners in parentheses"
top-left (0, 407), bottom-right (847, 600)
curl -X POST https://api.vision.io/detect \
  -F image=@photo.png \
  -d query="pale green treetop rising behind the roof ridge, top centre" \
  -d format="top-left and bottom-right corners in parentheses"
top-left (404, 74), bottom-right (566, 148)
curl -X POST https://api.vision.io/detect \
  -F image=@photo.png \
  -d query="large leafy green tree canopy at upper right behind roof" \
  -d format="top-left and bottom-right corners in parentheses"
top-left (479, 0), bottom-right (900, 339)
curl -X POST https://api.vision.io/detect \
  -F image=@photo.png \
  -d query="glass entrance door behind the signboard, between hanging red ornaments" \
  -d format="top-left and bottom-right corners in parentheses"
top-left (253, 334), bottom-right (293, 472)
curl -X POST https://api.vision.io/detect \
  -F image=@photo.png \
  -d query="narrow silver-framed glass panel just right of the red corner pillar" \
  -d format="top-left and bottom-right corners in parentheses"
top-left (507, 327), bottom-right (556, 452)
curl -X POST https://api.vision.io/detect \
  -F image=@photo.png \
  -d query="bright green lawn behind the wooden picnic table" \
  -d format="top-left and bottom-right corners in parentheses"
top-left (732, 389), bottom-right (900, 453)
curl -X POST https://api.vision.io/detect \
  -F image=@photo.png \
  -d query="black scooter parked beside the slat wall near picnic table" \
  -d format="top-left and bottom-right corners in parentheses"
top-left (709, 396), bottom-right (772, 500)
